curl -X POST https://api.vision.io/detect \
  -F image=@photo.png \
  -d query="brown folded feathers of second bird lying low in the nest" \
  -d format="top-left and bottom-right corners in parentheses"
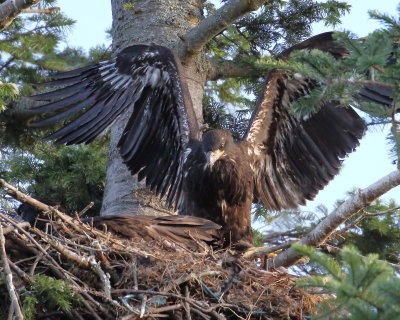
top-left (84, 214), bottom-right (221, 247)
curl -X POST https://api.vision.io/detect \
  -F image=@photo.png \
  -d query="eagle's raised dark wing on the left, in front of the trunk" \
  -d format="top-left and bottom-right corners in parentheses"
top-left (31, 45), bottom-right (199, 208)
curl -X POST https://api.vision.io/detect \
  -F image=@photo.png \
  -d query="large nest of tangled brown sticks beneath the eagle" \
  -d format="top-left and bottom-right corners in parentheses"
top-left (0, 179), bottom-right (321, 319)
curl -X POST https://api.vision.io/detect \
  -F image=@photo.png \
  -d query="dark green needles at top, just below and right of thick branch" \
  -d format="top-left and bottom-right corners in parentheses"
top-left (212, 0), bottom-right (350, 57)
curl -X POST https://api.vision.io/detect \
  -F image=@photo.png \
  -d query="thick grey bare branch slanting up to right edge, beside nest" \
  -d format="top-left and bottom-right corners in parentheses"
top-left (268, 170), bottom-right (400, 268)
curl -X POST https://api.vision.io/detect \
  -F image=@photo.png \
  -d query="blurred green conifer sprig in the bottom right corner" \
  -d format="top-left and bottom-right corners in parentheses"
top-left (293, 244), bottom-right (400, 320)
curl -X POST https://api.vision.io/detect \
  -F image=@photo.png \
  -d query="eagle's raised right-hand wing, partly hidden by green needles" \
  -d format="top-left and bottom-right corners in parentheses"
top-left (244, 33), bottom-right (391, 210)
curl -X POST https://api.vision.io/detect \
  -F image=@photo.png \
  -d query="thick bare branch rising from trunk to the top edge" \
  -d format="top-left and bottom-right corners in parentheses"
top-left (183, 0), bottom-right (268, 58)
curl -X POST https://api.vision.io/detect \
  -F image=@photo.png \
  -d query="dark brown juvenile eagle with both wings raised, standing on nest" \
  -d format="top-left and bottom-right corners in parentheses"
top-left (29, 33), bottom-right (390, 246)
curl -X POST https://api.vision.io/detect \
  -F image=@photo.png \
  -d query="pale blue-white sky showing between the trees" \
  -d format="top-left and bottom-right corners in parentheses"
top-left (58, 0), bottom-right (400, 210)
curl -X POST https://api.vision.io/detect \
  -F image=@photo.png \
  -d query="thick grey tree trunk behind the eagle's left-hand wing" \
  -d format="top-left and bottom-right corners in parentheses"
top-left (101, 0), bottom-right (209, 215)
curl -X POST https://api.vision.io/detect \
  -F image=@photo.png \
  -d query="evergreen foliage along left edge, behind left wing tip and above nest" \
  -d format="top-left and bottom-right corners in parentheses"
top-left (0, 0), bottom-right (110, 214)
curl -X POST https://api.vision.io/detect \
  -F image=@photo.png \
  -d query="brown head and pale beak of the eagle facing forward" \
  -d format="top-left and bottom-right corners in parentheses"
top-left (203, 130), bottom-right (234, 169)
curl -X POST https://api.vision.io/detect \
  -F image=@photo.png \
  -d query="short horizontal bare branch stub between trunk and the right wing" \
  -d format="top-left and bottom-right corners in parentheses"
top-left (207, 58), bottom-right (265, 81)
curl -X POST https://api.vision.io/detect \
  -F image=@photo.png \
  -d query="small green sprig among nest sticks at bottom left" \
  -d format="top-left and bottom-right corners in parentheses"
top-left (22, 275), bottom-right (79, 320)
